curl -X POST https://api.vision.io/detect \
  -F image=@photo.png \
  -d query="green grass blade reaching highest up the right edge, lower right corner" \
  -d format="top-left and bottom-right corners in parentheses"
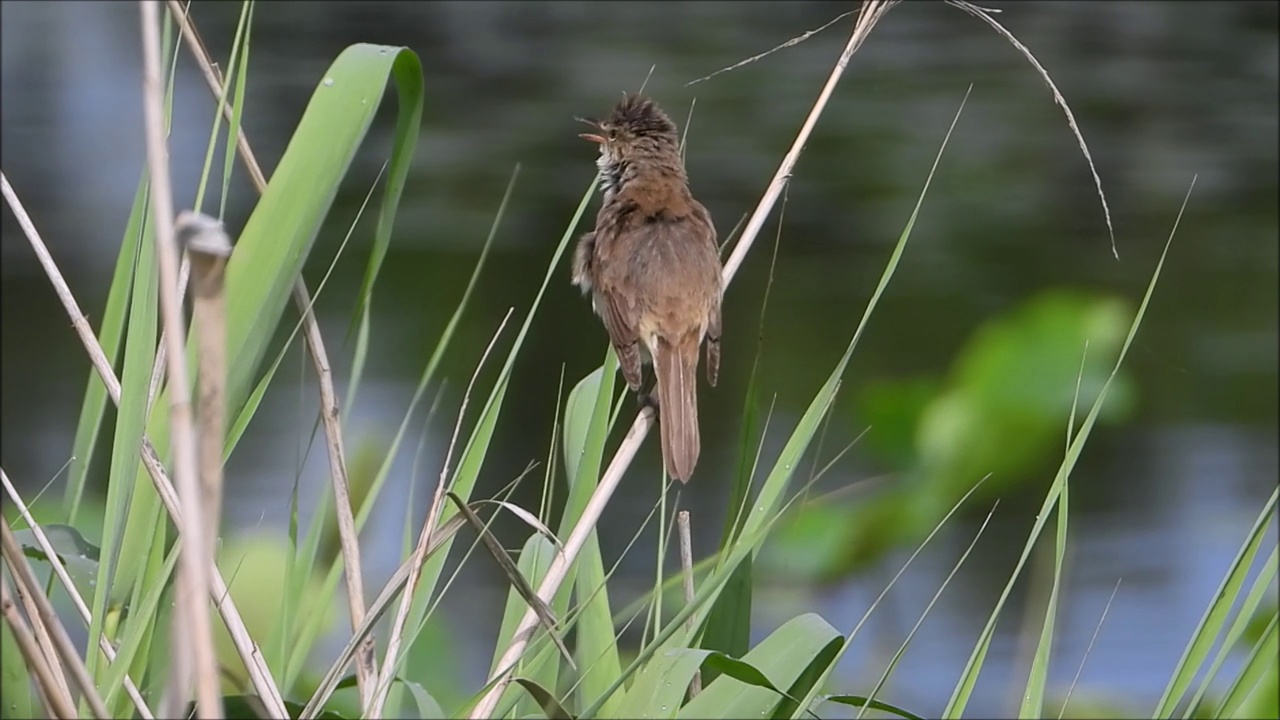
top-left (1152, 479), bottom-right (1280, 717)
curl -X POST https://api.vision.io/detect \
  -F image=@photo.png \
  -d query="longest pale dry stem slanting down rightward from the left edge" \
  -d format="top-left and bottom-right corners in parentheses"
top-left (0, 172), bottom-right (289, 719)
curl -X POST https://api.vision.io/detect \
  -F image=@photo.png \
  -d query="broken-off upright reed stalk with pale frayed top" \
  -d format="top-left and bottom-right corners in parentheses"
top-left (174, 210), bottom-right (232, 562)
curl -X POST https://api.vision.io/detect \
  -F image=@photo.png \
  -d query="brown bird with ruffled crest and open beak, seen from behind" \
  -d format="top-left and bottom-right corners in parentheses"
top-left (573, 95), bottom-right (723, 482)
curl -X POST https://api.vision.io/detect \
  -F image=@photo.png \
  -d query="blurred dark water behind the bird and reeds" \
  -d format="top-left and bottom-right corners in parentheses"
top-left (0, 1), bottom-right (1280, 714)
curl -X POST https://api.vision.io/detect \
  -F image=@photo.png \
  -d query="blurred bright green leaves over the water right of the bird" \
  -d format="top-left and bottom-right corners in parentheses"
top-left (767, 290), bottom-right (1134, 580)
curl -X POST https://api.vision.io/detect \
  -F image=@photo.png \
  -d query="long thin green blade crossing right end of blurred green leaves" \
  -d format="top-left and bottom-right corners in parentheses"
top-left (942, 174), bottom-right (1196, 717)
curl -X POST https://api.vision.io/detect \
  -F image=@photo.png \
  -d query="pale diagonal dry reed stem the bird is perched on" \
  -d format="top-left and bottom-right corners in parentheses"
top-left (470, 0), bottom-right (895, 719)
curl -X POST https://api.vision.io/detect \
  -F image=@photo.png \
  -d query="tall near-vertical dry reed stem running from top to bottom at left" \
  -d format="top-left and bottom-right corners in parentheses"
top-left (140, 0), bottom-right (223, 720)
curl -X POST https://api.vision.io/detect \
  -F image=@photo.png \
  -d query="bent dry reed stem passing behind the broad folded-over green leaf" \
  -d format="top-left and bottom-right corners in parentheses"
top-left (169, 0), bottom-right (378, 708)
